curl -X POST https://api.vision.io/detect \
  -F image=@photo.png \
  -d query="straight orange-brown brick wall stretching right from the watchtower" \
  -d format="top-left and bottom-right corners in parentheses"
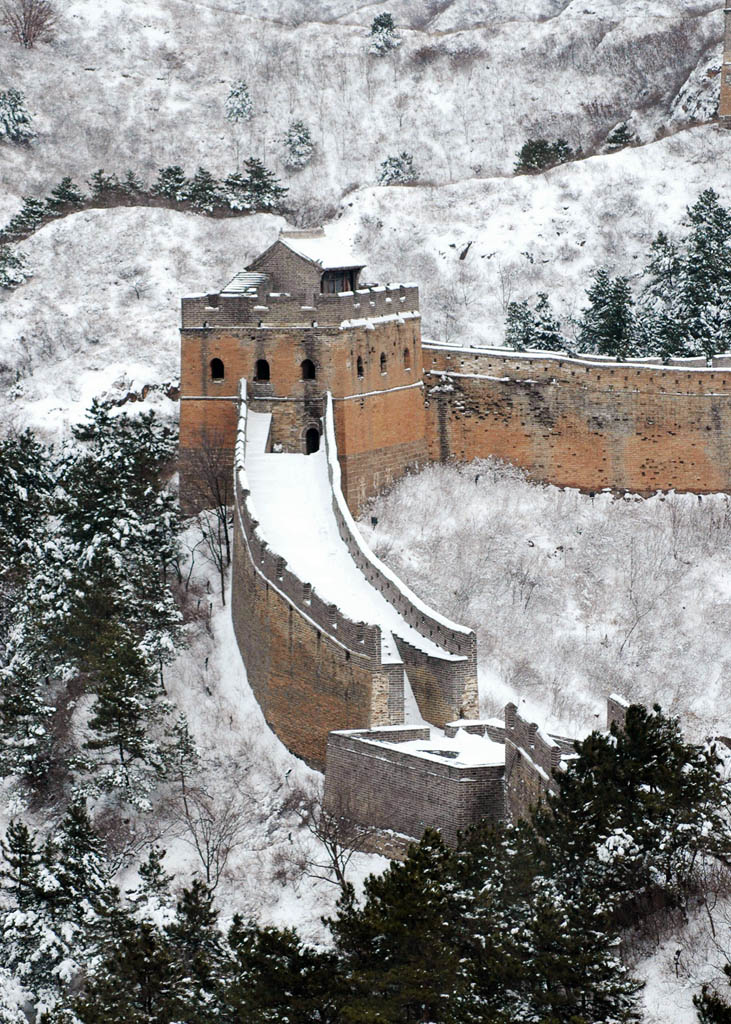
top-left (423, 344), bottom-right (731, 494)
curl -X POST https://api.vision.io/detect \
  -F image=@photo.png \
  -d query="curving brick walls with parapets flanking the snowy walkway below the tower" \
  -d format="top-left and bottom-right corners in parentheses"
top-left (231, 382), bottom-right (477, 768)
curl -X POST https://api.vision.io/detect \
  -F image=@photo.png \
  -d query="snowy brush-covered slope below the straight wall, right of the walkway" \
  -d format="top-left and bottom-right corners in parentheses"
top-left (359, 462), bottom-right (731, 737)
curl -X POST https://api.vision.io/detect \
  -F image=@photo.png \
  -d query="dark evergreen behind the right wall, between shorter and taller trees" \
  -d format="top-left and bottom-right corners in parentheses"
top-left (578, 269), bottom-right (635, 360)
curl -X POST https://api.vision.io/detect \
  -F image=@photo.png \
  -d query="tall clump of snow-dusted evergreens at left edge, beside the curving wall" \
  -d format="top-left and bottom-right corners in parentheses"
top-left (0, 403), bottom-right (179, 806)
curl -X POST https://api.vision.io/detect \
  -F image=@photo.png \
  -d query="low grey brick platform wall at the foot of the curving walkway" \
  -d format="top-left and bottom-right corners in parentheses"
top-left (325, 729), bottom-right (505, 845)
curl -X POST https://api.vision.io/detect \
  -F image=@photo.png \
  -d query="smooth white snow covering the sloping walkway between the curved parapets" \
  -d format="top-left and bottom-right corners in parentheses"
top-left (246, 411), bottom-right (461, 662)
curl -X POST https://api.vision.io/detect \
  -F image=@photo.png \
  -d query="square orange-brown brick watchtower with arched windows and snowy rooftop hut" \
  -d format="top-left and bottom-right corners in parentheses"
top-left (180, 228), bottom-right (427, 511)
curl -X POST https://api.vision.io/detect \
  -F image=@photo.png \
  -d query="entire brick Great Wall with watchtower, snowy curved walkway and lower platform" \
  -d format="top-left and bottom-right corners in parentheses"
top-left (180, 229), bottom-right (731, 842)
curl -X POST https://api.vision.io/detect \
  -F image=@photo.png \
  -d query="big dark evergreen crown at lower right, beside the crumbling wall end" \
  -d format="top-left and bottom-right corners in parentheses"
top-left (538, 705), bottom-right (731, 923)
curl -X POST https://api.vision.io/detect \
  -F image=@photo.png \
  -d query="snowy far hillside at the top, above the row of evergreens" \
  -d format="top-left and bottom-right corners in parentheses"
top-left (0, 0), bottom-right (722, 219)
